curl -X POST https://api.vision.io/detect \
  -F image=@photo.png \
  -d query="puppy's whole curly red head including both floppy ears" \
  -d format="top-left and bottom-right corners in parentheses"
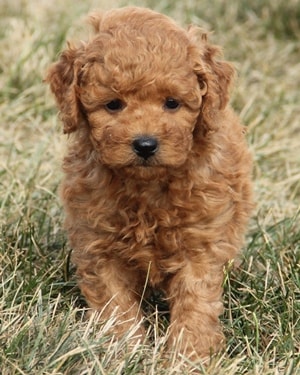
top-left (46, 8), bottom-right (233, 178)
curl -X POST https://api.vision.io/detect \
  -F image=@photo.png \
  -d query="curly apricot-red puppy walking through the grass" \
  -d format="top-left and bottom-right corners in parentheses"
top-left (47, 8), bottom-right (252, 358)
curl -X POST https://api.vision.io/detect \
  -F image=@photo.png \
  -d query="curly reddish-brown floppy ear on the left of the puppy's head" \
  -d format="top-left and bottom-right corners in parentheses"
top-left (45, 46), bottom-right (83, 133)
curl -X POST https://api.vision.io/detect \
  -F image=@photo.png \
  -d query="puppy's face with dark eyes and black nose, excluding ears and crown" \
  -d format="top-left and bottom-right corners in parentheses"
top-left (78, 47), bottom-right (202, 174)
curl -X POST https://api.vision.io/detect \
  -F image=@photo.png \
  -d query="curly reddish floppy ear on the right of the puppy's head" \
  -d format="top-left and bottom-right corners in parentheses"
top-left (188, 27), bottom-right (235, 130)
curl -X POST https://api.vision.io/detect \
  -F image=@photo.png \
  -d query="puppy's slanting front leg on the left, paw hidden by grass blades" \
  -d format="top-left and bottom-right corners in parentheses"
top-left (77, 261), bottom-right (145, 340)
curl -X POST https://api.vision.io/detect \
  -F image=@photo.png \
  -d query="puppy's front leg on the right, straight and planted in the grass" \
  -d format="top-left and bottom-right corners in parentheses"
top-left (168, 264), bottom-right (224, 359)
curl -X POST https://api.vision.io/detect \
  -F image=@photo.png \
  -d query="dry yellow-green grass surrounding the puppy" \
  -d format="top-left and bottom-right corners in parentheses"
top-left (0, 0), bottom-right (300, 375)
